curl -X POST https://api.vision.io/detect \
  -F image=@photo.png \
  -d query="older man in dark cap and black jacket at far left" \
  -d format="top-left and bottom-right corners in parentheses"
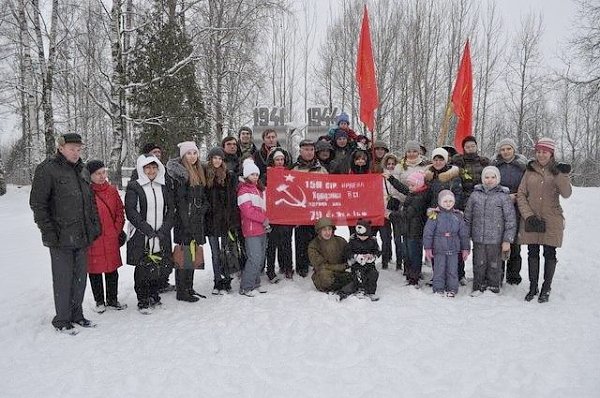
top-left (29, 133), bottom-right (100, 334)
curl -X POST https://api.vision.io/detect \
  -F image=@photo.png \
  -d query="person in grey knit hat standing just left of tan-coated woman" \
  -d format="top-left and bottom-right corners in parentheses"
top-left (493, 138), bottom-right (527, 285)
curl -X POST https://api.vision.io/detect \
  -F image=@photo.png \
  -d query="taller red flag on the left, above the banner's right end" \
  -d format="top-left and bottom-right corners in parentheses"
top-left (356, 5), bottom-right (379, 133)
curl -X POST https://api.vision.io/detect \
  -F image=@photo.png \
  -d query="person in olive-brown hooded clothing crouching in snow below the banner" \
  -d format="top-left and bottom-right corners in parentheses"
top-left (308, 217), bottom-right (356, 299)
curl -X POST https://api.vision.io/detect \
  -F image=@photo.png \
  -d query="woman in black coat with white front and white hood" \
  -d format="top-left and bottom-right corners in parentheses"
top-left (125, 154), bottom-right (175, 315)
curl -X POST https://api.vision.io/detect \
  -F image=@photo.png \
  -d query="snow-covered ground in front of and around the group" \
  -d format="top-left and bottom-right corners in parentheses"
top-left (0, 186), bottom-right (600, 398)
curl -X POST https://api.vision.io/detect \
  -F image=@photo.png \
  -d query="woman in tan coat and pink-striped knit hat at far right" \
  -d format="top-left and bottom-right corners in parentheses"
top-left (517, 137), bottom-right (572, 303)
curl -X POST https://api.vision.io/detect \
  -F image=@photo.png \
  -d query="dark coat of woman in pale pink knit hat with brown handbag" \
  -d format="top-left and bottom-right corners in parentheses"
top-left (167, 158), bottom-right (208, 245)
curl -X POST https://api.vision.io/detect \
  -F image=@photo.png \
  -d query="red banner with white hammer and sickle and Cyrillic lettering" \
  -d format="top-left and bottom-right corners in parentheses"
top-left (266, 168), bottom-right (384, 225)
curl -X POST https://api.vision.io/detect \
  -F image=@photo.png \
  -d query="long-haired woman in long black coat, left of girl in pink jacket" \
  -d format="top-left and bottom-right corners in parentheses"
top-left (206, 147), bottom-right (240, 295)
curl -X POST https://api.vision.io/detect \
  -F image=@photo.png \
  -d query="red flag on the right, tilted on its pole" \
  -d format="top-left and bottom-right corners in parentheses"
top-left (452, 40), bottom-right (473, 153)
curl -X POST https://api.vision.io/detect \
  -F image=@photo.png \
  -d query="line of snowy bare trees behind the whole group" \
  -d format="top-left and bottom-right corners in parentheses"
top-left (0, 0), bottom-right (600, 185)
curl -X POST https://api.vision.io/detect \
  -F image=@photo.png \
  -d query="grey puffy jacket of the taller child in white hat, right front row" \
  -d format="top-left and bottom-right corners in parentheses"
top-left (465, 184), bottom-right (517, 244)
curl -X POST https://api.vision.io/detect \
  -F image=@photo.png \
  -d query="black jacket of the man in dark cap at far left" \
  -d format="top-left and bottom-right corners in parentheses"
top-left (29, 153), bottom-right (100, 249)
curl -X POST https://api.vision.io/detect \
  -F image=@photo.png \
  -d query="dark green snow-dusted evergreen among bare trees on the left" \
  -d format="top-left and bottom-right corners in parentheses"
top-left (129, 17), bottom-right (206, 154)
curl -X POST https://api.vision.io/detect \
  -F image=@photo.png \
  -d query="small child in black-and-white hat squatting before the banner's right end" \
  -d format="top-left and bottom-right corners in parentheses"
top-left (348, 218), bottom-right (381, 301)
